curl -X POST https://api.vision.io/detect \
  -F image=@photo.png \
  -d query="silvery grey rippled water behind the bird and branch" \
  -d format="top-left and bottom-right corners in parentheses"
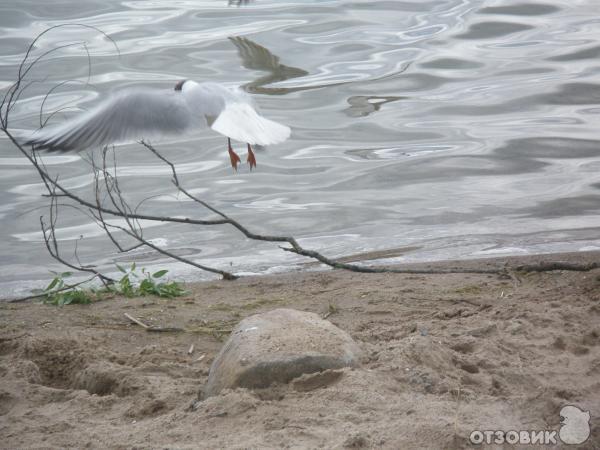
top-left (0, 0), bottom-right (600, 298)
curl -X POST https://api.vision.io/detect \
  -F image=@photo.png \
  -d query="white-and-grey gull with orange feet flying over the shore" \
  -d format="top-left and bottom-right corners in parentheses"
top-left (25, 80), bottom-right (290, 170)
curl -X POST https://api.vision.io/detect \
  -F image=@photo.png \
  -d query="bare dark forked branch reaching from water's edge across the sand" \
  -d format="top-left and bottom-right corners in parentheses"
top-left (0, 24), bottom-right (599, 298)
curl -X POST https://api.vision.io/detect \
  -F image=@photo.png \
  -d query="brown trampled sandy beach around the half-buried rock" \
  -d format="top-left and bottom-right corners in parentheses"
top-left (0, 253), bottom-right (600, 449)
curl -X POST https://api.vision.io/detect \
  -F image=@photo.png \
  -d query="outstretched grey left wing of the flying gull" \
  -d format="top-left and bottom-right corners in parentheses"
top-left (26, 89), bottom-right (192, 151)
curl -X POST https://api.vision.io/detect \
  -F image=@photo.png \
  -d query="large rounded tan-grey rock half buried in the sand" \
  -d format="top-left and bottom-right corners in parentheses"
top-left (204, 309), bottom-right (360, 397)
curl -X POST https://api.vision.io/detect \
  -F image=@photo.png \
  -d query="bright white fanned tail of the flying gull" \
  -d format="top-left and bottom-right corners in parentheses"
top-left (211, 102), bottom-right (291, 145)
